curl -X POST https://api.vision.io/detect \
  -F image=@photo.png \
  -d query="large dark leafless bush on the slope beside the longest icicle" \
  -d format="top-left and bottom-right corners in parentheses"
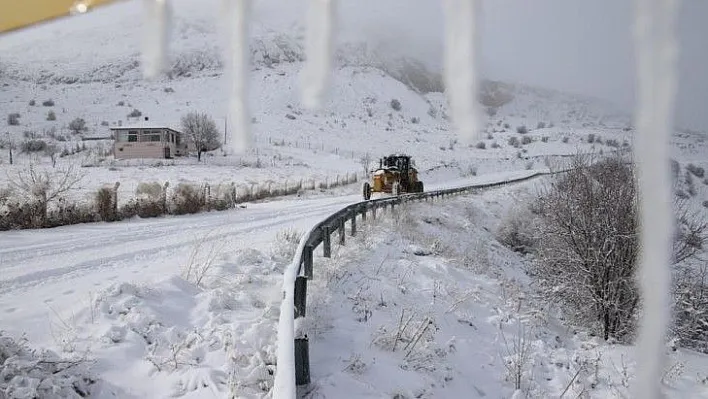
top-left (532, 156), bottom-right (705, 339)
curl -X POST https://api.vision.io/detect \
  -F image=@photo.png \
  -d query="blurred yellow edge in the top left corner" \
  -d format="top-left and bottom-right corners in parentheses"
top-left (0, 0), bottom-right (115, 33)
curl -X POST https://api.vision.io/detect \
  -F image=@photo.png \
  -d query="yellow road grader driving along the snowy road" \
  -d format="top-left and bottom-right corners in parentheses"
top-left (362, 154), bottom-right (423, 201)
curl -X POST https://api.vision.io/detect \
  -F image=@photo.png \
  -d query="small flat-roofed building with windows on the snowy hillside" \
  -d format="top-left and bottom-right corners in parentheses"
top-left (111, 126), bottom-right (189, 159)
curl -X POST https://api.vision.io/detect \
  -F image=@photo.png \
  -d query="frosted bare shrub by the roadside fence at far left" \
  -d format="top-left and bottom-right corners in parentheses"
top-left (8, 164), bottom-right (84, 227)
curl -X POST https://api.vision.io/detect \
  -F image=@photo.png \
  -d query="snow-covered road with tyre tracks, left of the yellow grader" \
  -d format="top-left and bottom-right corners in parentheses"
top-left (0, 195), bottom-right (359, 343)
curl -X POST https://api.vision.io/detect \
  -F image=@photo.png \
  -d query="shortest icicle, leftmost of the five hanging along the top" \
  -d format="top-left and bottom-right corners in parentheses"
top-left (143, 0), bottom-right (170, 79)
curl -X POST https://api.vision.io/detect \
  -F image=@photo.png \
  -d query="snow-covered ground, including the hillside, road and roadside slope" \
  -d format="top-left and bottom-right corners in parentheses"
top-left (0, 0), bottom-right (708, 399)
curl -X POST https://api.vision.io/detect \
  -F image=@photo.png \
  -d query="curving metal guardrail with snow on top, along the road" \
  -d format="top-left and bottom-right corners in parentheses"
top-left (274, 172), bottom-right (558, 398)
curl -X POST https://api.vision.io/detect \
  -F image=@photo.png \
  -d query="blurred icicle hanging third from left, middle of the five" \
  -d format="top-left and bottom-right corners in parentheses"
top-left (302, 0), bottom-right (336, 108)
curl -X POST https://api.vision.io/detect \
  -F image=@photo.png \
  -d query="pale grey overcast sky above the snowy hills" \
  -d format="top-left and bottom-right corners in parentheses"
top-left (334, 0), bottom-right (708, 130)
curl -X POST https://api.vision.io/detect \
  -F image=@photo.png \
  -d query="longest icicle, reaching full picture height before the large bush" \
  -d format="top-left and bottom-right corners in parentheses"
top-left (634, 0), bottom-right (678, 399)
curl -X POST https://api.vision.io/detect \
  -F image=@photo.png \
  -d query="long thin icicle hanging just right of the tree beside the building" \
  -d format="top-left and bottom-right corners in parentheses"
top-left (224, 0), bottom-right (252, 153)
